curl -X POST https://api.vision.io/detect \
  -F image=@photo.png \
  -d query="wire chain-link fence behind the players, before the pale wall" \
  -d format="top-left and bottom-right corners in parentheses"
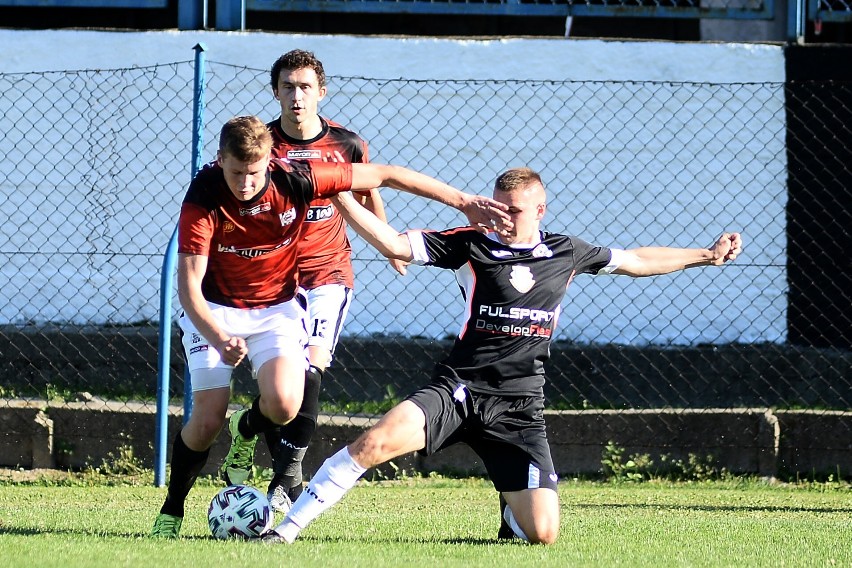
top-left (0, 57), bottom-right (852, 474)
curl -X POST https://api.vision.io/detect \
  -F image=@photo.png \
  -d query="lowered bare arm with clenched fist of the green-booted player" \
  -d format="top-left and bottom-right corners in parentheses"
top-left (177, 253), bottom-right (248, 366)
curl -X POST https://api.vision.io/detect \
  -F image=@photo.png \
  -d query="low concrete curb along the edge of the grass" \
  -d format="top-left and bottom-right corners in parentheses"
top-left (0, 399), bottom-right (852, 478)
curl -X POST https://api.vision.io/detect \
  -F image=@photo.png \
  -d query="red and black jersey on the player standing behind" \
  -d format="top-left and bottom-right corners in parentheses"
top-left (268, 117), bottom-right (369, 290)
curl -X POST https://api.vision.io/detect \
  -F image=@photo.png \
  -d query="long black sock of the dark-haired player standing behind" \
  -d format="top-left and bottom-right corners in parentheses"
top-left (266, 365), bottom-right (322, 491)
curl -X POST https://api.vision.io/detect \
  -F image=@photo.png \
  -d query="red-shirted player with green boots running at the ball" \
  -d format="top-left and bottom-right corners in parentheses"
top-left (152, 116), bottom-right (510, 537)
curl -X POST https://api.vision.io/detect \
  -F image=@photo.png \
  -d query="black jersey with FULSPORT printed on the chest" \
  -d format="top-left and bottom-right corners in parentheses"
top-left (409, 227), bottom-right (612, 395)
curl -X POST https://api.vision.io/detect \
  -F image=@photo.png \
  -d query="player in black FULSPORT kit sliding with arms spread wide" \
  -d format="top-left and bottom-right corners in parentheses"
top-left (263, 168), bottom-right (742, 544)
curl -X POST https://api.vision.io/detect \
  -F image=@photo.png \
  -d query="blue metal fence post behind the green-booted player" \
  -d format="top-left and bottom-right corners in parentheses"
top-left (154, 43), bottom-right (207, 487)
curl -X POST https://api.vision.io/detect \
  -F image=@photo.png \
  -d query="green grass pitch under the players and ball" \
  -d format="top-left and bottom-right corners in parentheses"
top-left (0, 478), bottom-right (852, 568)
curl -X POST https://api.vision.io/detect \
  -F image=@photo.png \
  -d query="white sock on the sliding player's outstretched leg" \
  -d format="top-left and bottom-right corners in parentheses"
top-left (275, 448), bottom-right (367, 542)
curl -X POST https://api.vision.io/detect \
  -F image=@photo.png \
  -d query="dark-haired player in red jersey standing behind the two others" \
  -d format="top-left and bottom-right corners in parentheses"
top-left (266, 49), bottom-right (405, 513)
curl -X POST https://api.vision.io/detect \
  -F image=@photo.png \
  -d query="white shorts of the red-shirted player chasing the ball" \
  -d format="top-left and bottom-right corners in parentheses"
top-left (178, 296), bottom-right (308, 391)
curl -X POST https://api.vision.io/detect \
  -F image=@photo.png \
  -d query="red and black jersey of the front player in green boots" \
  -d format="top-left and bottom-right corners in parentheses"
top-left (178, 158), bottom-right (352, 308)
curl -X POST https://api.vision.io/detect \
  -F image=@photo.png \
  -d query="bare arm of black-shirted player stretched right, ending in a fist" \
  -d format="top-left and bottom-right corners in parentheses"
top-left (613, 233), bottom-right (743, 277)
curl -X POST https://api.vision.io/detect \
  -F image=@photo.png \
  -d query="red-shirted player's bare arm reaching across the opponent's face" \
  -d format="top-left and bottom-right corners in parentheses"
top-left (352, 164), bottom-right (512, 232)
